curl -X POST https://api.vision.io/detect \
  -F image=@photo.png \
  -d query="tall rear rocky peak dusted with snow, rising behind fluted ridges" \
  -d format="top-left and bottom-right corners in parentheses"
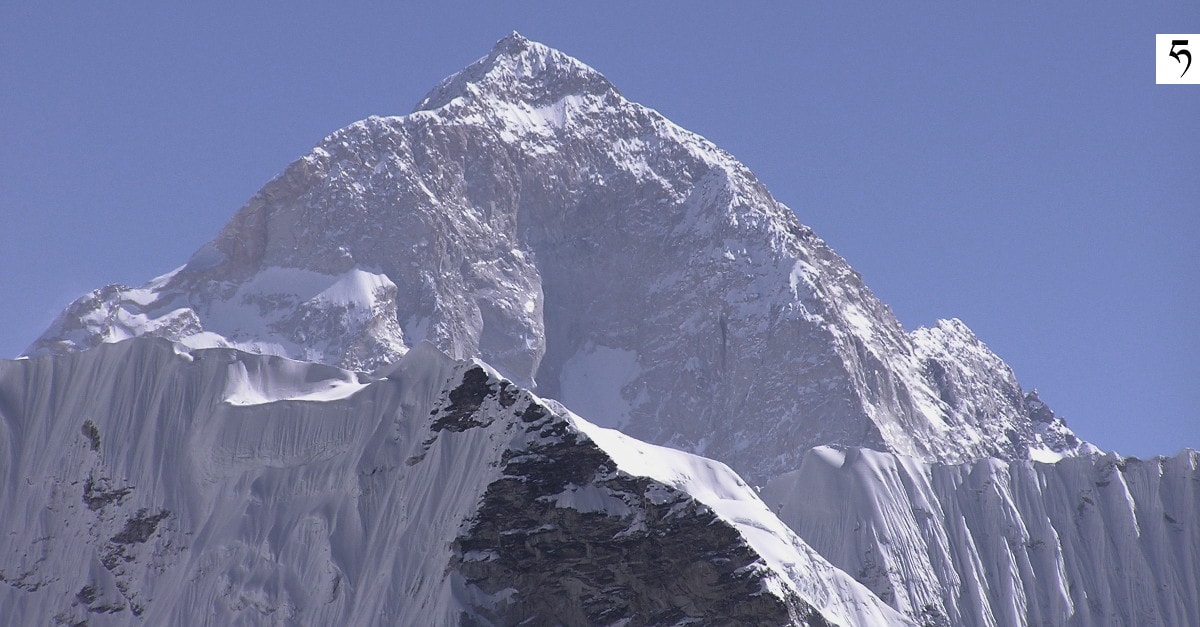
top-left (31, 35), bottom-right (1089, 480)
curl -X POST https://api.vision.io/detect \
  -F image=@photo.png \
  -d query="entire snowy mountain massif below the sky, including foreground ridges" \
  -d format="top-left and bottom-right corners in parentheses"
top-left (0, 34), bottom-right (1200, 626)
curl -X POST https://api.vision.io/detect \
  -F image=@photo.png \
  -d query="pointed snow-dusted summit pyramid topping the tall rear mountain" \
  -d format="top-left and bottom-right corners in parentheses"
top-left (415, 31), bottom-right (617, 111)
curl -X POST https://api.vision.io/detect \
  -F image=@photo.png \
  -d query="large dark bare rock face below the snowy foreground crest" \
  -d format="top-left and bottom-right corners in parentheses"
top-left (451, 404), bottom-right (826, 626)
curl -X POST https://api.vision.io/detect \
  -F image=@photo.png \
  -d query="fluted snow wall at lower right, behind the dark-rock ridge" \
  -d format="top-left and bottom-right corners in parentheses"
top-left (762, 447), bottom-right (1200, 626)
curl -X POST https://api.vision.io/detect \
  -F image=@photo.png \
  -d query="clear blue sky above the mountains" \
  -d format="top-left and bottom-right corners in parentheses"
top-left (0, 1), bottom-right (1200, 455)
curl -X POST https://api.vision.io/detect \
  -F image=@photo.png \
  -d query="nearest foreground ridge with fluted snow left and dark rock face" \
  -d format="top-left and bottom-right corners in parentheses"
top-left (0, 339), bottom-right (905, 625)
